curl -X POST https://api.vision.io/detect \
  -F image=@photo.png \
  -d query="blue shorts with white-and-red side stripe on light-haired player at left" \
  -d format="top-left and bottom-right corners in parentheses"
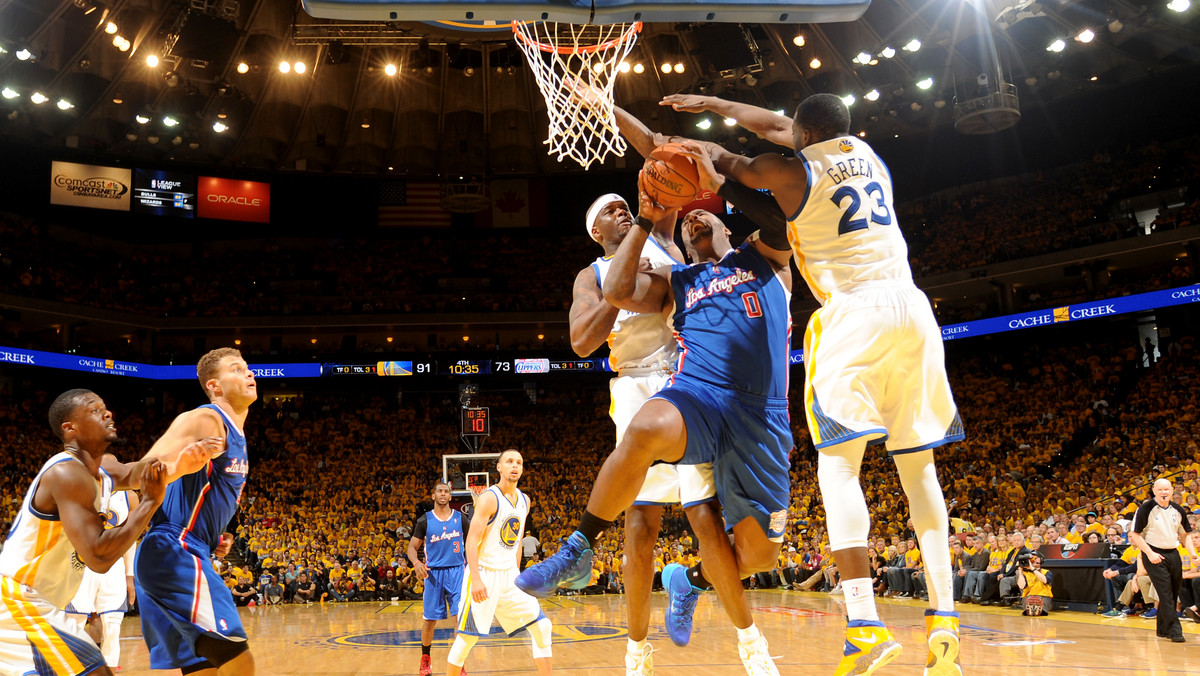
top-left (133, 525), bottom-right (246, 669)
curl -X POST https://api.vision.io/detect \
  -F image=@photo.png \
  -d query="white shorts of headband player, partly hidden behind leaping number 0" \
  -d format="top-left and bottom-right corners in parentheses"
top-left (608, 371), bottom-right (716, 507)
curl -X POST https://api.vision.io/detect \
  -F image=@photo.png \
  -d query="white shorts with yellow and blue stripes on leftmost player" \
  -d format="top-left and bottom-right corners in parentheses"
top-left (0, 575), bottom-right (104, 676)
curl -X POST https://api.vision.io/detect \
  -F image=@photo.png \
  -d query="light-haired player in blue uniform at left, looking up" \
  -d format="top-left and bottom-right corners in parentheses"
top-left (127, 347), bottom-right (258, 675)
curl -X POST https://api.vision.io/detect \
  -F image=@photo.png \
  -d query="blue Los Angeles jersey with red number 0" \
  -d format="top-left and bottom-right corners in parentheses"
top-left (671, 243), bottom-right (792, 397)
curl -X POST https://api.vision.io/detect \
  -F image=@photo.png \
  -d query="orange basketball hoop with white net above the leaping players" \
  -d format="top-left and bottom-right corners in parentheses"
top-left (512, 22), bottom-right (642, 169)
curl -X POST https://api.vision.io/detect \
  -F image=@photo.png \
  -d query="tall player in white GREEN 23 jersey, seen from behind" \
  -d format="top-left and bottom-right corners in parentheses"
top-left (662, 94), bottom-right (964, 676)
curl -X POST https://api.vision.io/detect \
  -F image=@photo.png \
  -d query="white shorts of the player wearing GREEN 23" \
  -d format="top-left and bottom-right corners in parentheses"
top-left (804, 283), bottom-right (962, 454)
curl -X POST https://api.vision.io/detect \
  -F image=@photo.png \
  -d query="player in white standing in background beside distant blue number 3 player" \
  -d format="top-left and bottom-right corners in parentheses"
top-left (446, 448), bottom-right (553, 676)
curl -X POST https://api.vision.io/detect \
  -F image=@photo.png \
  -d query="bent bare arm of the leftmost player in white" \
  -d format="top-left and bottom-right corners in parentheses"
top-left (47, 460), bottom-right (167, 573)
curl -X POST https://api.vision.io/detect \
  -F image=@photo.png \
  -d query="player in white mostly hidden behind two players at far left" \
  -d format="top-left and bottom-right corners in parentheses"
top-left (62, 459), bottom-right (138, 666)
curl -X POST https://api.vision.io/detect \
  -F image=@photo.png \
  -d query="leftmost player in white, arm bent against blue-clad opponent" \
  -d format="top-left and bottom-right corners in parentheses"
top-left (0, 389), bottom-right (182, 676)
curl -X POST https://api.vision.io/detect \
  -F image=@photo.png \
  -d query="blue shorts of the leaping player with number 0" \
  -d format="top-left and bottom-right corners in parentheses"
top-left (652, 376), bottom-right (793, 543)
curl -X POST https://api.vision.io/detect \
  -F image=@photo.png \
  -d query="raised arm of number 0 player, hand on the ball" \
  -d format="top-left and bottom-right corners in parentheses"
top-left (604, 173), bottom-right (679, 312)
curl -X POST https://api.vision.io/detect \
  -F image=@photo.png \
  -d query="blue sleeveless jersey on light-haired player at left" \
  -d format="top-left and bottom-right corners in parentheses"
top-left (151, 403), bottom-right (250, 549)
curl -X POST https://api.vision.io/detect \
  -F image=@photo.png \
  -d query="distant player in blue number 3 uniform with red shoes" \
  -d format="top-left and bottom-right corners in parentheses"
top-left (408, 481), bottom-right (467, 676)
